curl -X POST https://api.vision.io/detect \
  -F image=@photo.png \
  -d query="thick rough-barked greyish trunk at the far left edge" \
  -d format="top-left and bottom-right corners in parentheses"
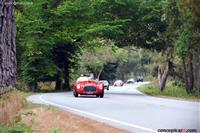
top-left (0, 0), bottom-right (17, 92)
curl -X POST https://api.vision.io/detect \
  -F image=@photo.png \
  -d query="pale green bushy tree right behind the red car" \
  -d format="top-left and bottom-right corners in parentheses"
top-left (80, 38), bottom-right (128, 79)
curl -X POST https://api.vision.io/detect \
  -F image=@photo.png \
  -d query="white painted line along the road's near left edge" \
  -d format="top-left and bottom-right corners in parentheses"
top-left (39, 95), bottom-right (157, 133)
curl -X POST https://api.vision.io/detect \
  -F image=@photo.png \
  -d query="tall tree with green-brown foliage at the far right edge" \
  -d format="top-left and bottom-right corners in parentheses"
top-left (175, 0), bottom-right (200, 93)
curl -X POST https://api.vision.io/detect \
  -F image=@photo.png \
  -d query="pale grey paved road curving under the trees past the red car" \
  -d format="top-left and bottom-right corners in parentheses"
top-left (28, 83), bottom-right (200, 133)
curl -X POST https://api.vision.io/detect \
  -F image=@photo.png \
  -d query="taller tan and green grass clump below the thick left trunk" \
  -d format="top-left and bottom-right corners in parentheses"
top-left (0, 90), bottom-right (30, 133)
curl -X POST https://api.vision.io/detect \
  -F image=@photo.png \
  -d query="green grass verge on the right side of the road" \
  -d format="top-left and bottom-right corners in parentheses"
top-left (139, 82), bottom-right (200, 100)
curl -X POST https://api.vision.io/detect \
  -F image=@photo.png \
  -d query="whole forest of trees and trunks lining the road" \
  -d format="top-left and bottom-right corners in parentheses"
top-left (0, 0), bottom-right (200, 94)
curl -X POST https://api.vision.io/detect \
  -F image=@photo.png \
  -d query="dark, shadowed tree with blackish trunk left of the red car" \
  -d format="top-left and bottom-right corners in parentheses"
top-left (52, 39), bottom-right (79, 91)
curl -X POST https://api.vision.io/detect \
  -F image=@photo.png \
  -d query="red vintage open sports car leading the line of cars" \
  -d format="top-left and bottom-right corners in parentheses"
top-left (73, 77), bottom-right (104, 98)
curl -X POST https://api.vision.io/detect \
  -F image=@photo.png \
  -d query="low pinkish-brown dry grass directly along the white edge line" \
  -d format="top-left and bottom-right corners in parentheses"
top-left (22, 106), bottom-right (128, 133)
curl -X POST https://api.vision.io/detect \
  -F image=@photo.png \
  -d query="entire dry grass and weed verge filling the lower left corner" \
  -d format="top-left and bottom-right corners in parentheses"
top-left (0, 91), bottom-right (128, 133)
